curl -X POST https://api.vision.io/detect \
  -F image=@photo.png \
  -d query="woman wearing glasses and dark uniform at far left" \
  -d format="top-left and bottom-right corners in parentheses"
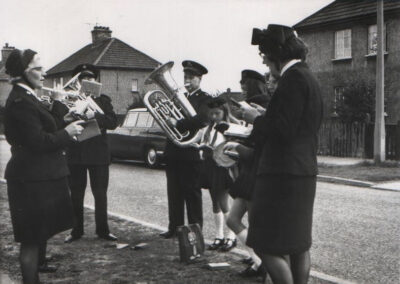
top-left (4, 49), bottom-right (83, 284)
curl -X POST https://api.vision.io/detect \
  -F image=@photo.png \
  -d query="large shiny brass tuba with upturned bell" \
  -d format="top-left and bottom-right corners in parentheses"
top-left (143, 61), bottom-right (201, 147)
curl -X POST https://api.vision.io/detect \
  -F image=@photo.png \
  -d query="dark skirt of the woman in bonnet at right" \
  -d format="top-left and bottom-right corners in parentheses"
top-left (247, 174), bottom-right (316, 255)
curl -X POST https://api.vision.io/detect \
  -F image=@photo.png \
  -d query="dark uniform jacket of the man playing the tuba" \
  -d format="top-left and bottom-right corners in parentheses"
top-left (165, 89), bottom-right (211, 161)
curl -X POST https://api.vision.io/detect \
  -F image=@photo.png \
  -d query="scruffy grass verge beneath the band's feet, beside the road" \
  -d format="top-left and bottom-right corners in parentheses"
top-left (0, 183), bottom-right (338, 284)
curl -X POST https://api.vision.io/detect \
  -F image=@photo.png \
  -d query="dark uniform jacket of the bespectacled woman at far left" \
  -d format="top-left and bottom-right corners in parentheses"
top-left (4, 85), bottom-right (71, 181)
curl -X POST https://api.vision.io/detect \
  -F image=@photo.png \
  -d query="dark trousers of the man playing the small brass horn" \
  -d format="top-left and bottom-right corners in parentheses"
top-left (68, 165), bottom-right (110, 237)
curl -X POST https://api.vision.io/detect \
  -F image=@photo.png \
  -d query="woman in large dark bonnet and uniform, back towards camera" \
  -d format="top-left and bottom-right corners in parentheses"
top-left (227, 25), bottom-right (322, 284)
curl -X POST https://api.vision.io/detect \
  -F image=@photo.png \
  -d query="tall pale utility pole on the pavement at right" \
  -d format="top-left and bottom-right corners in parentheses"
top-left (374, 0), bottom-right (386, 163)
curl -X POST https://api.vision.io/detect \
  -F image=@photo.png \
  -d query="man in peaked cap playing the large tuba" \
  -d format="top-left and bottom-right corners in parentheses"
top-left (160, 60), bottom-right (211, 238)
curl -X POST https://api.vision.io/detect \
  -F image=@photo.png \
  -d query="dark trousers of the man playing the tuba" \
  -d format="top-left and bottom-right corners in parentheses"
top-left (166, 160), bottom-right (203, 231)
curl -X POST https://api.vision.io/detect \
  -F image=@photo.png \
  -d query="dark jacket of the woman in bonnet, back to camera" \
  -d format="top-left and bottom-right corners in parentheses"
top-left (249, 62), bottom-right (322, 176)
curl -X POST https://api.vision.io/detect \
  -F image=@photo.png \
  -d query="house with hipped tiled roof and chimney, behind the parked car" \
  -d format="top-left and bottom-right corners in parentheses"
top-left (44, 26), bottom-right (160, 115)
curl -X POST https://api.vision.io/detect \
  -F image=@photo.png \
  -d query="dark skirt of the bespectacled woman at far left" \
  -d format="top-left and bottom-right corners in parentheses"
top-left (7, 178), bottom-right (73, 244)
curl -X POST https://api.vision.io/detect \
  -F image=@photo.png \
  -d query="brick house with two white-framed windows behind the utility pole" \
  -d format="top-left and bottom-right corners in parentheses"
top-left (294, 0), bottom-right (400, 124)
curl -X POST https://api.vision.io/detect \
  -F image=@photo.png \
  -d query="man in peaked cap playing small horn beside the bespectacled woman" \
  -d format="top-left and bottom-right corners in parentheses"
top-left (65, 64), bottom-right (117, 243)
